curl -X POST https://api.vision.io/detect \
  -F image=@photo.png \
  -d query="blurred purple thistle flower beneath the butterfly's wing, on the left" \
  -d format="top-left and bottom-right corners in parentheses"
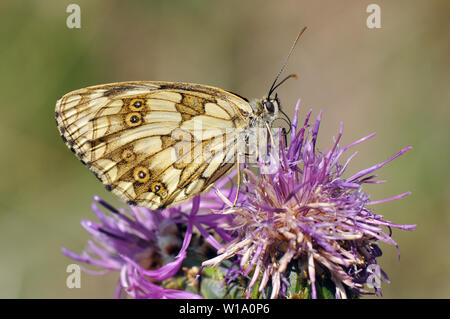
top-left (62, 178), bottom-right (242, 299)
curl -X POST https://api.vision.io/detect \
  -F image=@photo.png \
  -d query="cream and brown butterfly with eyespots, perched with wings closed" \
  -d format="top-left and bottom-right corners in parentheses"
top-left (55, 30), bottom-right (304, 210)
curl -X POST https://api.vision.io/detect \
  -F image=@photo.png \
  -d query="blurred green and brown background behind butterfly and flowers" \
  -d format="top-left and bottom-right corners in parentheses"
top-left (0, 0), bottom-right (450, 298)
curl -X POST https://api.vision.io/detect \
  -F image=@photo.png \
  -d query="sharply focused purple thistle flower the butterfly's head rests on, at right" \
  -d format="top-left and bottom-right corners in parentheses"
top-left (203, 100), bottom-right (415, 298)
